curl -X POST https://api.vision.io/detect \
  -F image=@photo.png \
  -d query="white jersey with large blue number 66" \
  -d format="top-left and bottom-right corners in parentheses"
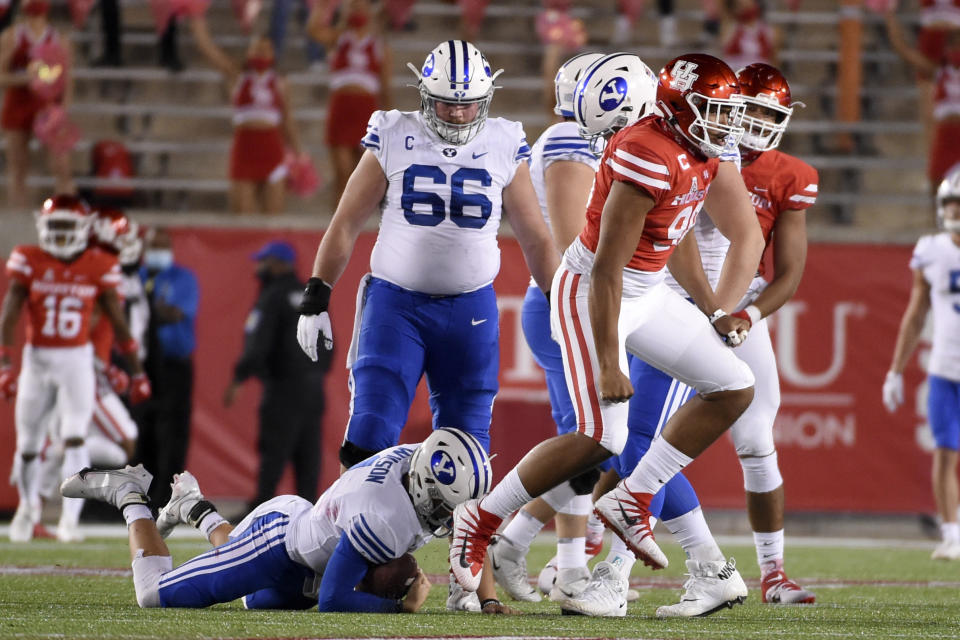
top-left (362, 110), bottom-right (530, 295)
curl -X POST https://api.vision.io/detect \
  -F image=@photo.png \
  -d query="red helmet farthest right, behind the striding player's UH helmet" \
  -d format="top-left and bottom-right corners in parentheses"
top-left (737, 62), bottom-right (794, 152)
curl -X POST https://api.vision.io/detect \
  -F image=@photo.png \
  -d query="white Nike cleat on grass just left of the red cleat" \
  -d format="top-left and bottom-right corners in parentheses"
top-left (657, 558), bottom-right (747, 618)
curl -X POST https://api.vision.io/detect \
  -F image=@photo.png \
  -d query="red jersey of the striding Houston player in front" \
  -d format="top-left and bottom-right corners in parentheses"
top-left (580, 117), bottom-right (720, 272)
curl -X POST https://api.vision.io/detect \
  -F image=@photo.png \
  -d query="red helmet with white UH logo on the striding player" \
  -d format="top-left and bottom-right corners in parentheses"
top-left (657, 53), bottom-right (744, 158)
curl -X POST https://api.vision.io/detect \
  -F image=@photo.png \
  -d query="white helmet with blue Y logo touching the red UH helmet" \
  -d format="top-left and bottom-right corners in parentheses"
top-left (573, 53), bottom-right (657, 151)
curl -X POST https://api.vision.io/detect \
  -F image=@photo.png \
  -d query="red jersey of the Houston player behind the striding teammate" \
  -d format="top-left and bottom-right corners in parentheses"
top-left (740, 149), bottom-right (819, 275)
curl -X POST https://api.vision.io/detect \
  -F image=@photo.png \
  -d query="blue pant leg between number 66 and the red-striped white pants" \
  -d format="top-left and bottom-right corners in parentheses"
top-left (521, 287), bottom-right (577, 435)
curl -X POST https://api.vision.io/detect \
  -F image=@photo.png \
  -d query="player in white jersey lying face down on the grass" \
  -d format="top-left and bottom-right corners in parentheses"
top-left (61, 429), bottom-right (493, 613)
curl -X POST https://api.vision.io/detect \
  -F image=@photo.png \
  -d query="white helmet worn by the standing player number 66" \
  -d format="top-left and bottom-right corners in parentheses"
top-left (407, 40), bottom-right (503, 145)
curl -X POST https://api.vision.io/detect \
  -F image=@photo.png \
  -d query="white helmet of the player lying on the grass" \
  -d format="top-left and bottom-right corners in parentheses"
top-left (407, 428), bottom-right (493, 536)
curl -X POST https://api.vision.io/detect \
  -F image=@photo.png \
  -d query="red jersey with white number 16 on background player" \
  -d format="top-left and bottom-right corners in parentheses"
top-left (7, 246), bottom-right (120, 347)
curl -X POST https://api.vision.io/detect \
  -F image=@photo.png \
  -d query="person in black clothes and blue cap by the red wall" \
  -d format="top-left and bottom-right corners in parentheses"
top-left (223, 241), bottom-right (331, 505)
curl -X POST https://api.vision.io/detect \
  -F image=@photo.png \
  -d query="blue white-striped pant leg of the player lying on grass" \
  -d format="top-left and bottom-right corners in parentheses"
top-left (158, 512), bottom-right (313, 608)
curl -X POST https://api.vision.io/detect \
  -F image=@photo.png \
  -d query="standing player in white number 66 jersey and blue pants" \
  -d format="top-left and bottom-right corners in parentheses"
top-left (297, 40), bottom-right (559, 468)
